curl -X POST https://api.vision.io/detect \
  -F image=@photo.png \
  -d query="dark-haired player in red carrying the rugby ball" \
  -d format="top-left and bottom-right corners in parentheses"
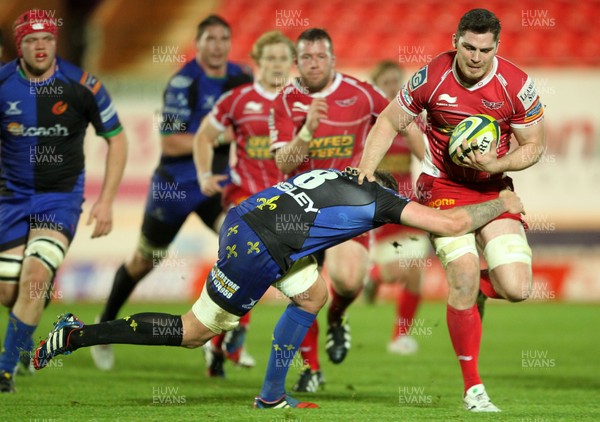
top-left (360, 9), bottom-right (545, 412)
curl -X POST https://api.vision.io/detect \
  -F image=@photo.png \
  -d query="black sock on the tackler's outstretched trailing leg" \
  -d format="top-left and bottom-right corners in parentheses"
top-left (69, 312), bottom-right (183, 350)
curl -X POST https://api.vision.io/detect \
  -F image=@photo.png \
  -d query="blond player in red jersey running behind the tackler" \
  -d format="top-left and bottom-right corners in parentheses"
top-left (194, 31), bottom-right (295, 376)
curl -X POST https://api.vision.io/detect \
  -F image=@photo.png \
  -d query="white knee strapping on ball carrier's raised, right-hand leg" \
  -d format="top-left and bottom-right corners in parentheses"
top-left (483, 234), bottom-right (531, 270)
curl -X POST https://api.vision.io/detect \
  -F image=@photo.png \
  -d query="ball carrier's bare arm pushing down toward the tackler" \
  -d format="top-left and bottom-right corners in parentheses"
top-left (358, 101), bottom-right (414, 184)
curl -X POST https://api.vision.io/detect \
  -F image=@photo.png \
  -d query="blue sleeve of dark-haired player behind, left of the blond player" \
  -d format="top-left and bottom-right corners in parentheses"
top-left (160, 74), bottom-right (196, 135)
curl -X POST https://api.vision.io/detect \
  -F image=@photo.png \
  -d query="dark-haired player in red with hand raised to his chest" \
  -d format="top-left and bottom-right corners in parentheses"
top-left (271, 28), bottom-right (388, 392)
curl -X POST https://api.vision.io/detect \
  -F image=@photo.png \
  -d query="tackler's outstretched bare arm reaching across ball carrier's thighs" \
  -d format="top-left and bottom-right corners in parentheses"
top-left (400, 190), bottom-right (523, 236)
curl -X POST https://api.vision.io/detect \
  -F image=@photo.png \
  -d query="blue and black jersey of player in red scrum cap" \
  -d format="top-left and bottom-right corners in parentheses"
top-left (0, 57), bottom-right (123, 195)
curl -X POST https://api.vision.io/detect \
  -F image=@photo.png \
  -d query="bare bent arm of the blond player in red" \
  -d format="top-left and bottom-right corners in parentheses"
top-left (193, 114), bottom-right (227, 196)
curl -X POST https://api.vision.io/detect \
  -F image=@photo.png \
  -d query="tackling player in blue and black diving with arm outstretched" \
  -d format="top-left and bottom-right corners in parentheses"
top-left (33, 168), bottom-right (523, 408)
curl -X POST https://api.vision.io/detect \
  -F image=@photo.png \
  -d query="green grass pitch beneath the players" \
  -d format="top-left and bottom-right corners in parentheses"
top-left (0, 303), bottom-right (600, 422)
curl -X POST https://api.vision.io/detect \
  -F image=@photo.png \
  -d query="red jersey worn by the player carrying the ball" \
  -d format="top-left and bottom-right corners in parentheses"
top-left (396, 51), bottom-right (544, 182)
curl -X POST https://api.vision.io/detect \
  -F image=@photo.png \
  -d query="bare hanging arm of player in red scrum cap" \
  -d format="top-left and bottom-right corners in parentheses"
top-left (87, 131), bottom-right (127, 238)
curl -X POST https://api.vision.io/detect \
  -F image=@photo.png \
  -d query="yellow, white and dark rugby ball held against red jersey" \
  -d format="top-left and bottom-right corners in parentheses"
top-left (448, 114), bottom-right (500, 165)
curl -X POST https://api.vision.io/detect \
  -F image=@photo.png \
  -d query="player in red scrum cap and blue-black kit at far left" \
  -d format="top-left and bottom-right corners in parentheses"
top-left (0, 9), bottom-right (127, 393)
